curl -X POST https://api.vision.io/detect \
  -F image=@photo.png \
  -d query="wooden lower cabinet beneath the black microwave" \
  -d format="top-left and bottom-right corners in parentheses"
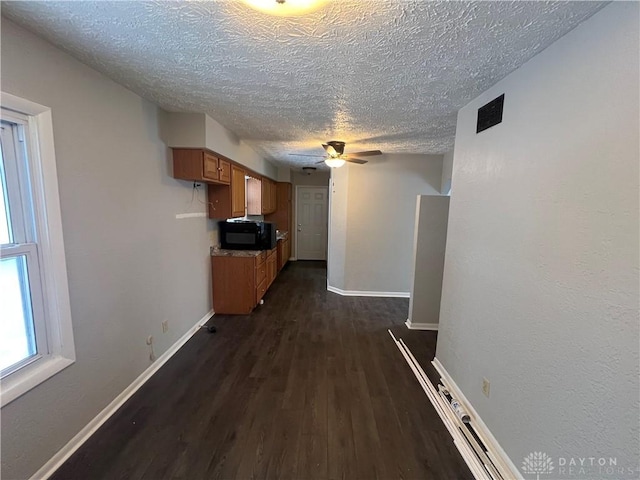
top-left (211, 248), bottom-right (278, 315)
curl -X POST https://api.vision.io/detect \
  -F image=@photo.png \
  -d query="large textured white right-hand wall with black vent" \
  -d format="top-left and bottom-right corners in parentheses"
top-left (436, 2), bottom-right (640, 478)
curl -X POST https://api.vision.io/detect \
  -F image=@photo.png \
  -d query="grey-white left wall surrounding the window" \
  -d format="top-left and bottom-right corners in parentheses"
top-left (1, 19), bottom-right (211, 478)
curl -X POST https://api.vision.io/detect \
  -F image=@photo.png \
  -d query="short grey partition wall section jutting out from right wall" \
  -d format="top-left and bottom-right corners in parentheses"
top-left (407, 195), bottom-right (449, 328)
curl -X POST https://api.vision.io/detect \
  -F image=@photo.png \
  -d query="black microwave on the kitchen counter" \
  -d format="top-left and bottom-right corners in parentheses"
top-left (218, 221), bottom-right (276, 250)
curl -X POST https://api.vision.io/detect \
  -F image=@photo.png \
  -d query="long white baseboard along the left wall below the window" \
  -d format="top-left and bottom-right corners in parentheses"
top-left (31, 310), bottom-right (214, 480)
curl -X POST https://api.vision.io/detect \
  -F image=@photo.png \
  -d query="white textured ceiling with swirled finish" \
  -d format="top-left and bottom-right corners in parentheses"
top-left (2, 0), bottom-right (604, 169)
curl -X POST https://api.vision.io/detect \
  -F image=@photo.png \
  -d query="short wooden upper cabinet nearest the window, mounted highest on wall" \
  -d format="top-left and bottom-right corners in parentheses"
top-left (173, 148), bottom-right (230, 184)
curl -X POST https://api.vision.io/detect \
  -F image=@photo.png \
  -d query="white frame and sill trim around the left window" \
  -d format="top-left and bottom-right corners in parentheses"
top-left (0, 92), bottom-right (76, 407)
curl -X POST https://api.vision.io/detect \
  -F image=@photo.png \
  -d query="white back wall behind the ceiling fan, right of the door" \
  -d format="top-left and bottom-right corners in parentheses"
top-left (338, 154), bottom-right (442, 296)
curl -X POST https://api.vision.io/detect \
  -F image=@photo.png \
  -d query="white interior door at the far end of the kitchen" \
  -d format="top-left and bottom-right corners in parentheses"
top-left (296, 186), bottom-right (328, 260)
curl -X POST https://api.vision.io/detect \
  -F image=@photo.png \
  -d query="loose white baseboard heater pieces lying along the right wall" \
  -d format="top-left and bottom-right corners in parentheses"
top-left (389, 330), bottom-right (512, 480)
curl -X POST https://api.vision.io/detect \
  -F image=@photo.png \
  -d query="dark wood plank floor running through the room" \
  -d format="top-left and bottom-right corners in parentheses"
top-left (52, 262), bottom-right (473, 480)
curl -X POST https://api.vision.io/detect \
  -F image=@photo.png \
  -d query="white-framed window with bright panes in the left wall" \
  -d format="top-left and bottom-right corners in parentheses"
top-left (0, 93), bottom-right (75, 406)
